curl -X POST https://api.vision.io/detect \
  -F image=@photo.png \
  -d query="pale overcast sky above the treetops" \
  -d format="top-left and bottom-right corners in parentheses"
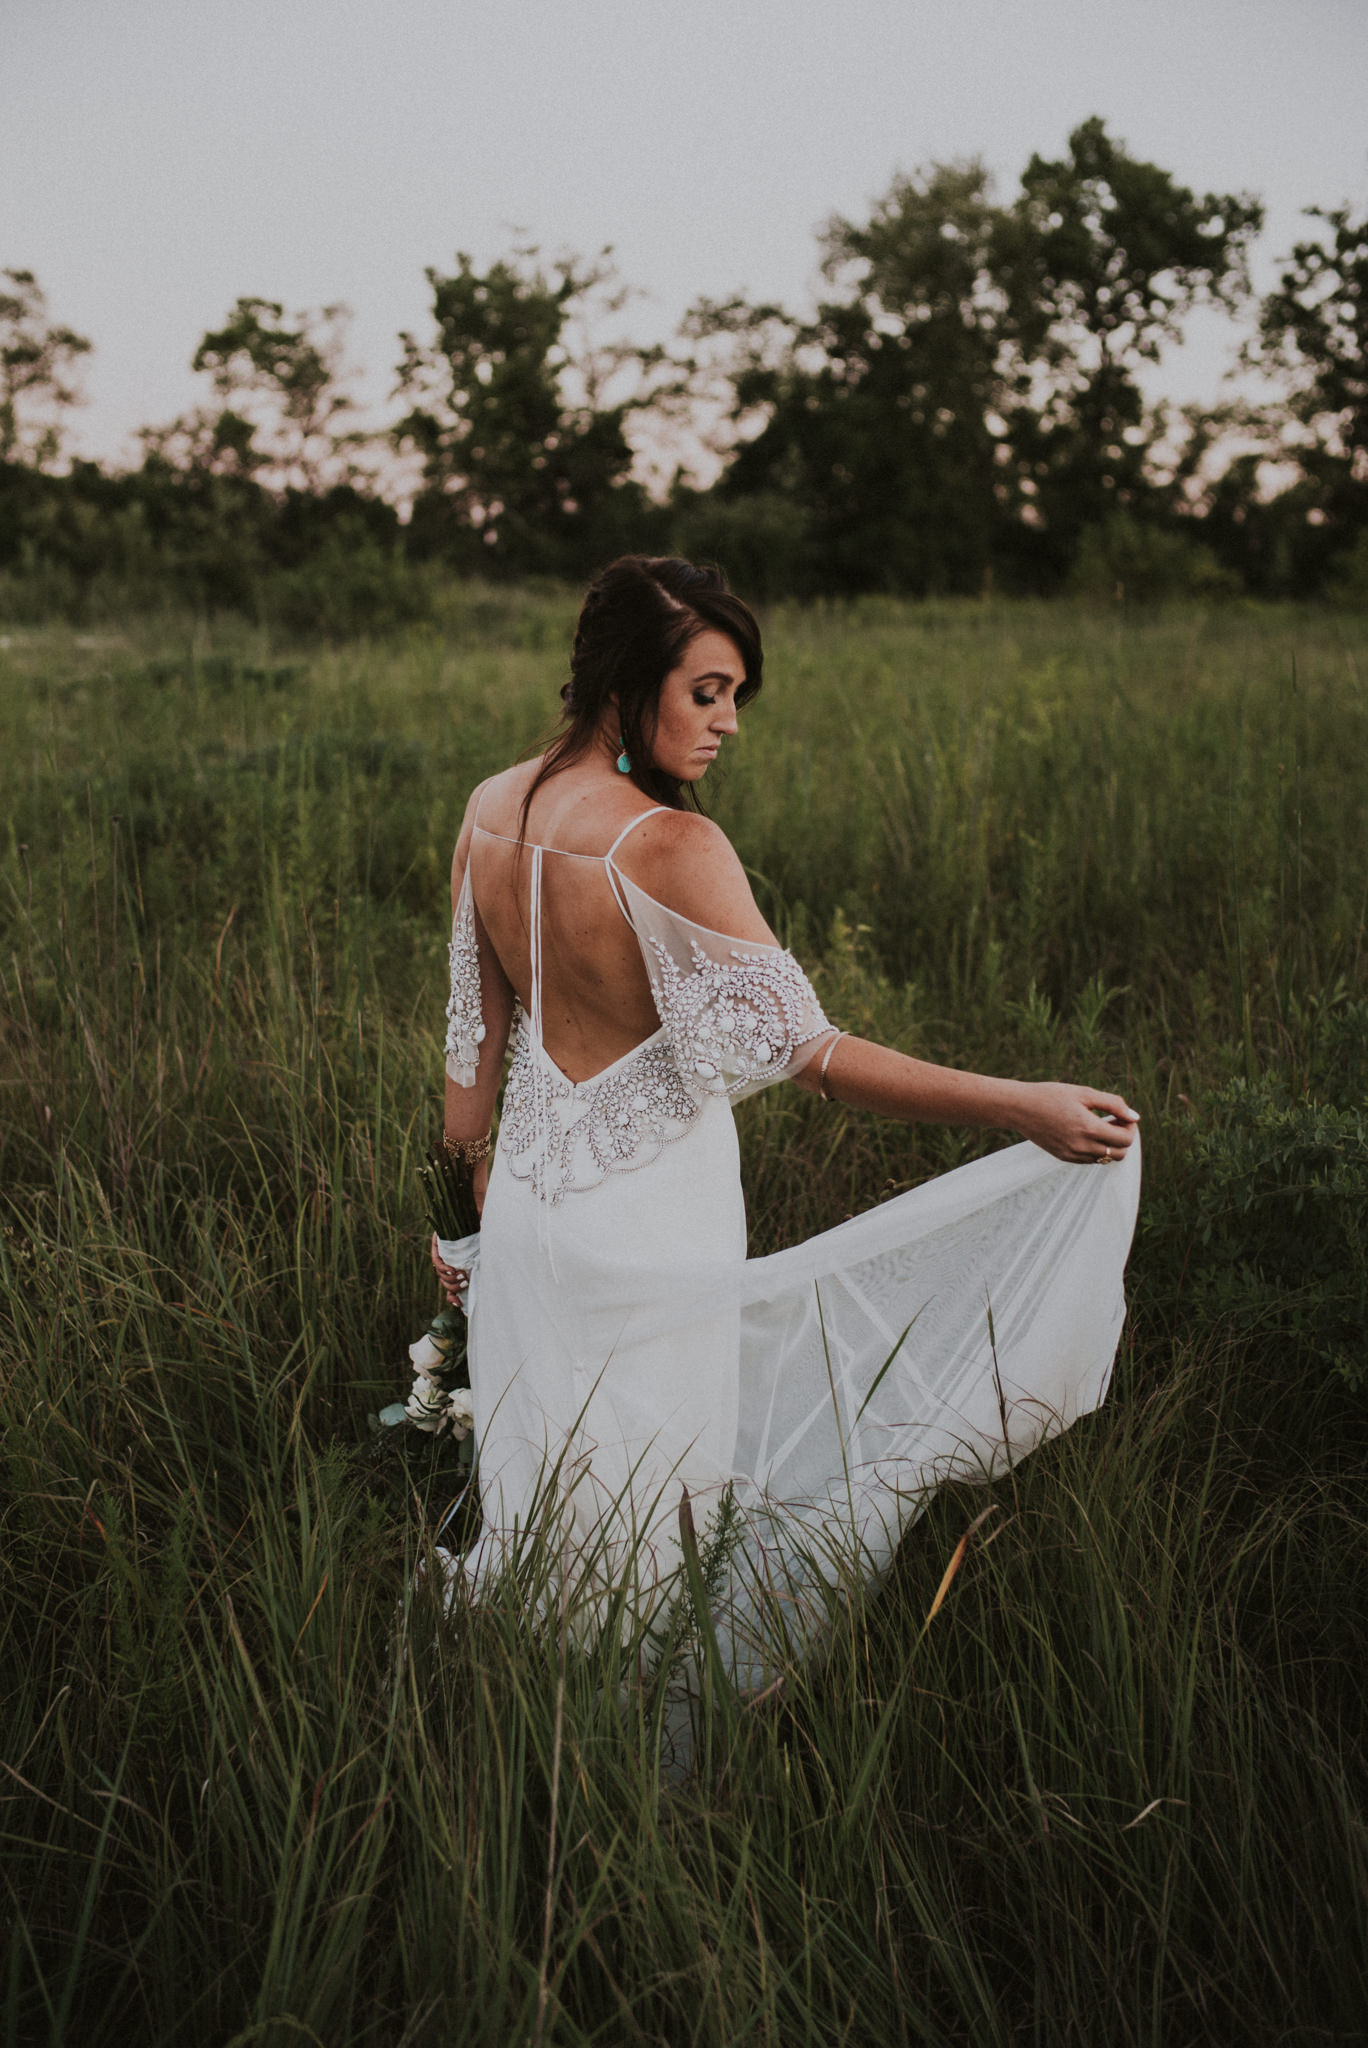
top-left (0, 0), bottom-right (1368, 468)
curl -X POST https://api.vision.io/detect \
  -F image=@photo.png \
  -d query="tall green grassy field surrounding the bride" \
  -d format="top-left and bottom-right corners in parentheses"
top-left (0, 592), bottom-right (1368, 2048)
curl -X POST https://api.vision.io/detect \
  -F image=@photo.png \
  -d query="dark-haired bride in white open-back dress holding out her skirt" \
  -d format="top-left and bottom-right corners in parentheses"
top-left (432, 555), bottom-right (1139, 1686)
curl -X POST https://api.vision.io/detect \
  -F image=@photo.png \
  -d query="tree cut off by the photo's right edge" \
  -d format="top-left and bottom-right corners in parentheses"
top-left (1247, 207), bottom-right (1368, 559)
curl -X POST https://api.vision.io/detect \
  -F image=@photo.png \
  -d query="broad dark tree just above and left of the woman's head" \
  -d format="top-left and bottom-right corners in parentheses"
top-left (393, 250), bottom-right (659, 573)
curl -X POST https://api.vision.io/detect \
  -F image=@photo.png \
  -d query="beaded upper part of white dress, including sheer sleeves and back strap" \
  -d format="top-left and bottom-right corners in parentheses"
top-left (446, 813), bottom-right (831, 1202)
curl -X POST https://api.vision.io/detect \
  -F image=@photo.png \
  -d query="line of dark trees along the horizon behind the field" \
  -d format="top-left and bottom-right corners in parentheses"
top-left (0, 119), bottom-right (1368, 629)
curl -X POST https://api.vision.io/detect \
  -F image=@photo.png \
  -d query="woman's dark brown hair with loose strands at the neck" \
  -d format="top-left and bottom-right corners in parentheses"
top-left (520, 555), bottom-right (764, 831)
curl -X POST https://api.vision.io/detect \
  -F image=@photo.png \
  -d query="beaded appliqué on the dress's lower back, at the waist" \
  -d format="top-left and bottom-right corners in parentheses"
top-left (500, 1016), bottom-right (698, 1202)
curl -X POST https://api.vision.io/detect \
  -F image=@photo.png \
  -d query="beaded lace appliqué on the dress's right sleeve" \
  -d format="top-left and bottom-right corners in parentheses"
top-left (651, 938), bottom-right (831, 1096)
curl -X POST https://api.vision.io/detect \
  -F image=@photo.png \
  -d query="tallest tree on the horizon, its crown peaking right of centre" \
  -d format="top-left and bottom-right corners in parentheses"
top-left (991, 117), bottom-right (1264, 571)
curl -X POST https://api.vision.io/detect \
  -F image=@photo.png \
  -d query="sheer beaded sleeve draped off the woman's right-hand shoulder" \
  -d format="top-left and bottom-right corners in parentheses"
top-left (616, 868), bottom-right (831, 1098)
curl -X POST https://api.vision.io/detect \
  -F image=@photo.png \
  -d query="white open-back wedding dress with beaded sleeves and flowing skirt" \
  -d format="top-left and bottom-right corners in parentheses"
top-left (446, 813), bottom-right (1139, 1690)
